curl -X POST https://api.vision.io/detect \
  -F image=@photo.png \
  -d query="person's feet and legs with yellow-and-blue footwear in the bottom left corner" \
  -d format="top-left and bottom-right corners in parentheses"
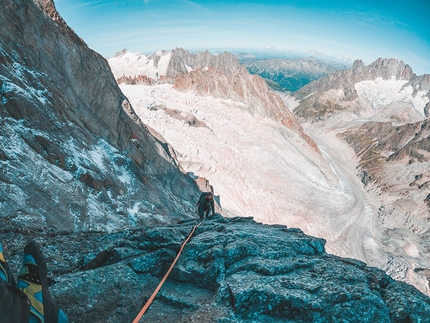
top-left (0, 241), bottom-right (68, 323)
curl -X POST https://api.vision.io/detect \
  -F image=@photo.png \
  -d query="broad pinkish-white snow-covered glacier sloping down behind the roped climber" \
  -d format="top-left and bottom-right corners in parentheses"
top-left (120, 84), bottom-right (378, 259)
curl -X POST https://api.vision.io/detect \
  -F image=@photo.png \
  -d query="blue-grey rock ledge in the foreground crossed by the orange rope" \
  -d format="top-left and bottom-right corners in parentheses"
top-left (4, 215), bottom-right (430, 323)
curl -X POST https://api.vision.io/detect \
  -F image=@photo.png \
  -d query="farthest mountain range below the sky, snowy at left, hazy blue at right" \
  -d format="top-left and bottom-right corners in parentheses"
top-left (109, 48), bottom-right (350, 92)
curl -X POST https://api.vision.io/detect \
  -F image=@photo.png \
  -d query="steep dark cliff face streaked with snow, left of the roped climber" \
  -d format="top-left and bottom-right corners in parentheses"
top-left (0, 0), bottom-right (198, 231)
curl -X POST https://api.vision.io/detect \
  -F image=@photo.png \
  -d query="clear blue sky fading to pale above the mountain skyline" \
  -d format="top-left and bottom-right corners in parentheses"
top-left (55, 0), bottom-right (430, 74)
